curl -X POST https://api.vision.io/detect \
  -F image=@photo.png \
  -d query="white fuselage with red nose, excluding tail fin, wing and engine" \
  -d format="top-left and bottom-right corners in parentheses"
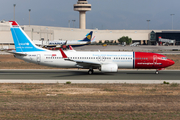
top-left (15, 51), bottom-right (174, 69)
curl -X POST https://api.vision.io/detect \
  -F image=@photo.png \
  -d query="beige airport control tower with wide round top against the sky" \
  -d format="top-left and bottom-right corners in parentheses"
top-left (74, 0), bottom-right (91, 29)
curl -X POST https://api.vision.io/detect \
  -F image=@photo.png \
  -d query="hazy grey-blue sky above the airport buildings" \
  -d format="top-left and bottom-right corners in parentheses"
top-left (0, 0), bottom-right (180, 30)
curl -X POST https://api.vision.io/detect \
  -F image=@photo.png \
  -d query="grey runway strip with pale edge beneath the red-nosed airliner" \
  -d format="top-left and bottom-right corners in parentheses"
top-left (0, 69), bottom-right (180, 83)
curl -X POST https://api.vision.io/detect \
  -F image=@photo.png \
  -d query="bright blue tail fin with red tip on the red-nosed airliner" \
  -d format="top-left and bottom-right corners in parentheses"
top-left (9, 21), bottom-right (47, 52)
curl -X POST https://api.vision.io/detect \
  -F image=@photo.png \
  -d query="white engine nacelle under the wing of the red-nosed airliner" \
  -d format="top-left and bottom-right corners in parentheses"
top-left (101, 64), bottom-right (118, 72)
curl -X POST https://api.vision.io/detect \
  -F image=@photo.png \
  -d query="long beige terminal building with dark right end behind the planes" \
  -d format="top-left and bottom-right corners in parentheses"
top-left (0, 21), bottom-right (180, 49)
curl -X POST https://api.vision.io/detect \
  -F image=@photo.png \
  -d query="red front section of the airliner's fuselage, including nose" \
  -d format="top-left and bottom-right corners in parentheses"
top-left (134, 52), bottom-right (174, 69)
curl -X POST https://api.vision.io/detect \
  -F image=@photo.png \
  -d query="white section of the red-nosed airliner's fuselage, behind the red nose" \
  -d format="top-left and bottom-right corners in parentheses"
top-left (15, 51), bottom-right (134, 68)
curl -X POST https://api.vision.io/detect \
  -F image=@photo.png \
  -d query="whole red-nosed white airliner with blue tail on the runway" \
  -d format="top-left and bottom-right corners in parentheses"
top-left (9, 21), bottom-right (174, 74)
